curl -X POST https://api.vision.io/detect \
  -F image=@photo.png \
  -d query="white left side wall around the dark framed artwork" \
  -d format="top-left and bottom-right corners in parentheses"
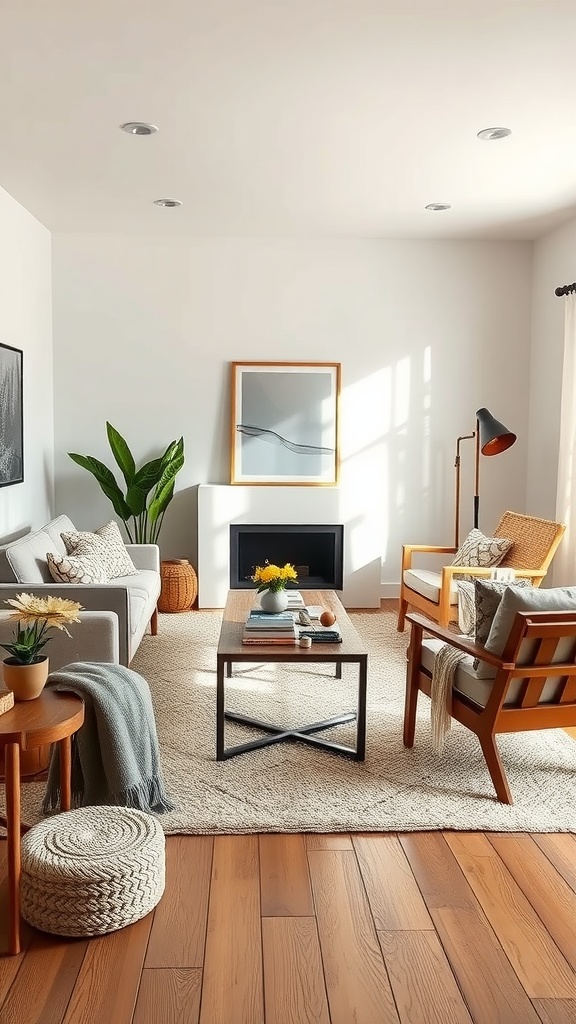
top-left (0, 182), bottom-right (53, 544)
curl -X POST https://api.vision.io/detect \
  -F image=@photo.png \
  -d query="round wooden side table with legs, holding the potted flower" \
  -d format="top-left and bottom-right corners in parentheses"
top-left (0, 689), bottom-right (84, 954)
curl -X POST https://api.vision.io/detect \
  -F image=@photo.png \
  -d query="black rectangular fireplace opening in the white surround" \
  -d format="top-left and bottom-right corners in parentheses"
top-left (230, 524), bottom-right (344, 590)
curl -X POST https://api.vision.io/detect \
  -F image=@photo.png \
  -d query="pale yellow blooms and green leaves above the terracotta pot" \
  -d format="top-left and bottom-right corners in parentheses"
top-left (0, 594), bottom-right (82, 665)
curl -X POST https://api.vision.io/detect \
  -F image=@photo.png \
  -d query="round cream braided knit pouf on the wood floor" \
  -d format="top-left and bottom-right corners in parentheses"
top-left (20, 806), bottom-right (165, 936)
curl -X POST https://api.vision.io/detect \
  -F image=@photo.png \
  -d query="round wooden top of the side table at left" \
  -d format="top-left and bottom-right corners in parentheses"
top-left (0, 689), bottom-right (84, 750)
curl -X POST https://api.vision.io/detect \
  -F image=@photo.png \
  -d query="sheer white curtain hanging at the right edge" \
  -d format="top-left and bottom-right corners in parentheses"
top-left (553, 293), bottom-right (576, 587)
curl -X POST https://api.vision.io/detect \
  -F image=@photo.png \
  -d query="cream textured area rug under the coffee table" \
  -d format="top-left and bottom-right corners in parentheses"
top-left (10, 611), bottom-right (576, 834)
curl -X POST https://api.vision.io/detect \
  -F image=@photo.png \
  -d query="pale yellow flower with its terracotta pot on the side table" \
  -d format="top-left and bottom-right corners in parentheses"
top-left (0, 594), bottom-right (82, 700)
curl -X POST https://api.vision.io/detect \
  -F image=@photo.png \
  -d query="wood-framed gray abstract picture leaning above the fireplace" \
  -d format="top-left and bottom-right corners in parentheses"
top-left (231, 362), bottom-right (340, 486)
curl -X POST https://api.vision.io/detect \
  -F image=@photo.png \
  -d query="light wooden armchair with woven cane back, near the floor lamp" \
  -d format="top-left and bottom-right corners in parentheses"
top-left (398, 512), bottom-right (566, 633)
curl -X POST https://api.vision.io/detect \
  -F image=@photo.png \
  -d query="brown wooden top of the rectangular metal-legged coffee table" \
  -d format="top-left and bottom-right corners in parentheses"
top-left (218, 590), bottom-right (367, 662)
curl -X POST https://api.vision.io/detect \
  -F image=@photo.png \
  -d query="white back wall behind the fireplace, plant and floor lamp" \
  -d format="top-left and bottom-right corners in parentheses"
top-left (53, 233), bottom-right (531, 584)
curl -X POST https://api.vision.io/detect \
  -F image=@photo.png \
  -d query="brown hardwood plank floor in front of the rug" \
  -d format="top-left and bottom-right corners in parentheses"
top-left (0, 602), bottom-right (576, 1024)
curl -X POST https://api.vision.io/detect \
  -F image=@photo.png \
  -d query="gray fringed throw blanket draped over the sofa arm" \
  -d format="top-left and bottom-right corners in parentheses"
top-left (42, 662), bottom-right (174, 814)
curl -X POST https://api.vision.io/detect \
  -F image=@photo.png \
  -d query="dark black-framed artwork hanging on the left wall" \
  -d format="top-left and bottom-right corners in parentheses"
top-left (0, 344), bottom-right (24, 487)
